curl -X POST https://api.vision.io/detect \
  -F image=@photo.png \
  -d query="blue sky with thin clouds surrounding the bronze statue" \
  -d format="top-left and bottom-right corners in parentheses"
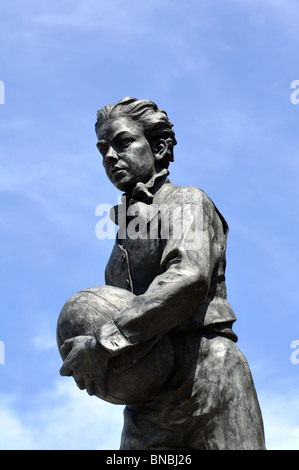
top-left (0, 0), bottom-right (299, 450)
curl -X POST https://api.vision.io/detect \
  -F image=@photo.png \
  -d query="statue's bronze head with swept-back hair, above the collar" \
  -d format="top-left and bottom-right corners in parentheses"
top-left (95, 97), bottom-right (177, 191)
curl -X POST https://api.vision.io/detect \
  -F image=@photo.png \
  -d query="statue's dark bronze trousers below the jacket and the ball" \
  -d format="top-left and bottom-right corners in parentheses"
top-left (120, 329), bottom-right (266, 450)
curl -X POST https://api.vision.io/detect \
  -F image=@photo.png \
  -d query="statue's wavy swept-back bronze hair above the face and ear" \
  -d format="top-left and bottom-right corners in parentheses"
top-left (95, 96), bottom-right (177, 167)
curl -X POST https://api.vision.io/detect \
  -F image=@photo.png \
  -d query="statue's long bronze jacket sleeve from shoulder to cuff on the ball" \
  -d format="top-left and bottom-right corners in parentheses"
top-left (97, 188), bottom-right (214, 355)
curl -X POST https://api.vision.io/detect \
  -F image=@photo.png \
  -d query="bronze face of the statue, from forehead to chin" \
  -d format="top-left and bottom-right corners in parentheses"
top-left (97, 117), bottom-right (156, 192)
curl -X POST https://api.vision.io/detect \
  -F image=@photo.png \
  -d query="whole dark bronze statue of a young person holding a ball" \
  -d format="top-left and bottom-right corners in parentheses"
top-left (57, 97), bottom-right (265, 450)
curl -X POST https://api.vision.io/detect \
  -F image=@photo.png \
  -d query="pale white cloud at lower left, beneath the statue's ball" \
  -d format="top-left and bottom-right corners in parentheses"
top-left (0, 379), bottom-right (122, 450)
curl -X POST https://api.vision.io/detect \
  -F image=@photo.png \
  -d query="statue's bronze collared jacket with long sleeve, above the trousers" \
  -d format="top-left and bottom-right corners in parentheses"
top-left (97, 170), bottom-right (236, 355)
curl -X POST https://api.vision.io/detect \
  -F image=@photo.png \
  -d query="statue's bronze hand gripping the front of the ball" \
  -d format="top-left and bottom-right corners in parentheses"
top-left (60, 336), bottom-right (111, 395)
